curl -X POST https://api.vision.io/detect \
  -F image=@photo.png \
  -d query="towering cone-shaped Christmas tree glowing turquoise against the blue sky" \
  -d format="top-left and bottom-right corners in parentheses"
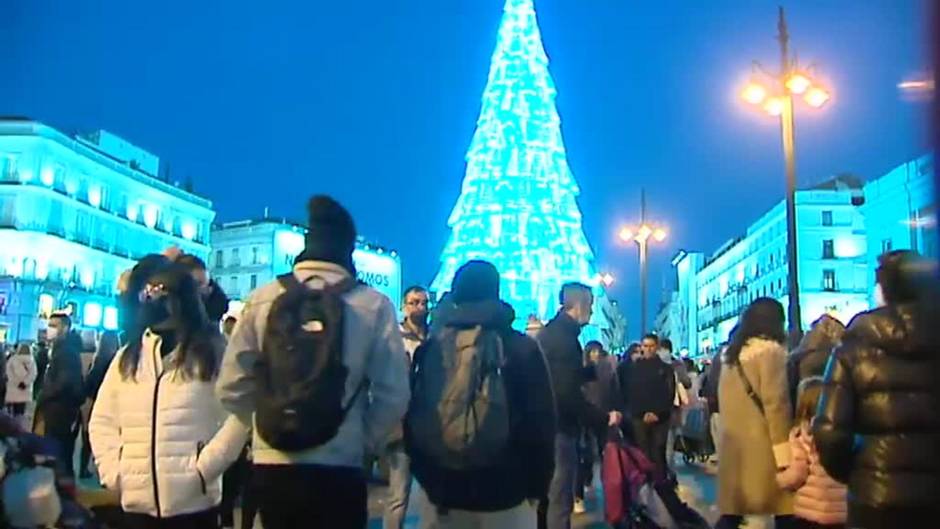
top-left (432, 0), bottom-right (606, 334)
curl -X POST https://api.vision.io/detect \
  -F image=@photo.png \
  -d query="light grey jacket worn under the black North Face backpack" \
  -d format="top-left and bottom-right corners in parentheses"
top-left (222, 261), bottom-right (411, 467)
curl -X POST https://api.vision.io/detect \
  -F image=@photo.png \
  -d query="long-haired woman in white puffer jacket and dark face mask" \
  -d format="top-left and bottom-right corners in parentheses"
top-left (90, 264), bottom-right (247, 529)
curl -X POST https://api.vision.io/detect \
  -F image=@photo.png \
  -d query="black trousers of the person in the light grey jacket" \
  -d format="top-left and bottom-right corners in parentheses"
top-left (252, 465), bottom-right (369, 529)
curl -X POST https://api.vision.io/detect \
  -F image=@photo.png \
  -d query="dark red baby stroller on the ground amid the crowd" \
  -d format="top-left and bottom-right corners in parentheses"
top-left (601, 428), bottom-right (711, 529)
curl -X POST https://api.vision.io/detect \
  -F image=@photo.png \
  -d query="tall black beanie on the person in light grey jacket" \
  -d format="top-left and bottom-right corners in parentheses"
top-left (300, 195), bottom-right (356, 276)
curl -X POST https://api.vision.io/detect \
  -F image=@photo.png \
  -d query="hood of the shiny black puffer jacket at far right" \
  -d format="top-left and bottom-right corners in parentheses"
top-left (843, 303), bottom-right (936, 357)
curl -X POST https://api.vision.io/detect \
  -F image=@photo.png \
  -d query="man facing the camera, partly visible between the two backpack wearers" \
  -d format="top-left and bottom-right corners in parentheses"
top-left (383, 285), bottom-right (428, 529)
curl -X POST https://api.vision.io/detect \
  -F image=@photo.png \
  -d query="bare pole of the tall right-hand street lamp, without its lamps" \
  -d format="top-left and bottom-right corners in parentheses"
top-left (777, 7), bottom-right (802, 347)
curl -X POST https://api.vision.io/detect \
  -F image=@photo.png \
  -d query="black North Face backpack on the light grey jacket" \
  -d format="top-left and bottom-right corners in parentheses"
top-left (255, 273), bottom-right (366, 452)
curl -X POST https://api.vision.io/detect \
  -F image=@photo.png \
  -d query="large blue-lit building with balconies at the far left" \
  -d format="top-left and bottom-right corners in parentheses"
top-left (0, 119), bottom-right (215, 342)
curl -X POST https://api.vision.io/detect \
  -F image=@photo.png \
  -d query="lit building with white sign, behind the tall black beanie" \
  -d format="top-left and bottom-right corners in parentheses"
top-left (207, 217), bottom-right (402, 308)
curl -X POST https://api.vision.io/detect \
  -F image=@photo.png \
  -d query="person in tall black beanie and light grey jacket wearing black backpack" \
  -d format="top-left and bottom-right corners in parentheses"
top-left (222, 195), bottom-right (410, 529)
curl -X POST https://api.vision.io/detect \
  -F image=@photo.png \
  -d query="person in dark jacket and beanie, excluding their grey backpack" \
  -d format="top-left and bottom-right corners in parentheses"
top-left (405, 261), bottom-right (555, 529)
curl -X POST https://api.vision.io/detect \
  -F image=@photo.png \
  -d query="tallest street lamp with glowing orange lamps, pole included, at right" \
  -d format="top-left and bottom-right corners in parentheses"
top-left (741, 7), bottom-right (830, 345)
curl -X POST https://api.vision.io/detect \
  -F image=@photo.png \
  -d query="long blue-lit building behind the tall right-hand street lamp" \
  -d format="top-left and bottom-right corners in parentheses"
top-left (669, 176), bottom-right (869, 356)
